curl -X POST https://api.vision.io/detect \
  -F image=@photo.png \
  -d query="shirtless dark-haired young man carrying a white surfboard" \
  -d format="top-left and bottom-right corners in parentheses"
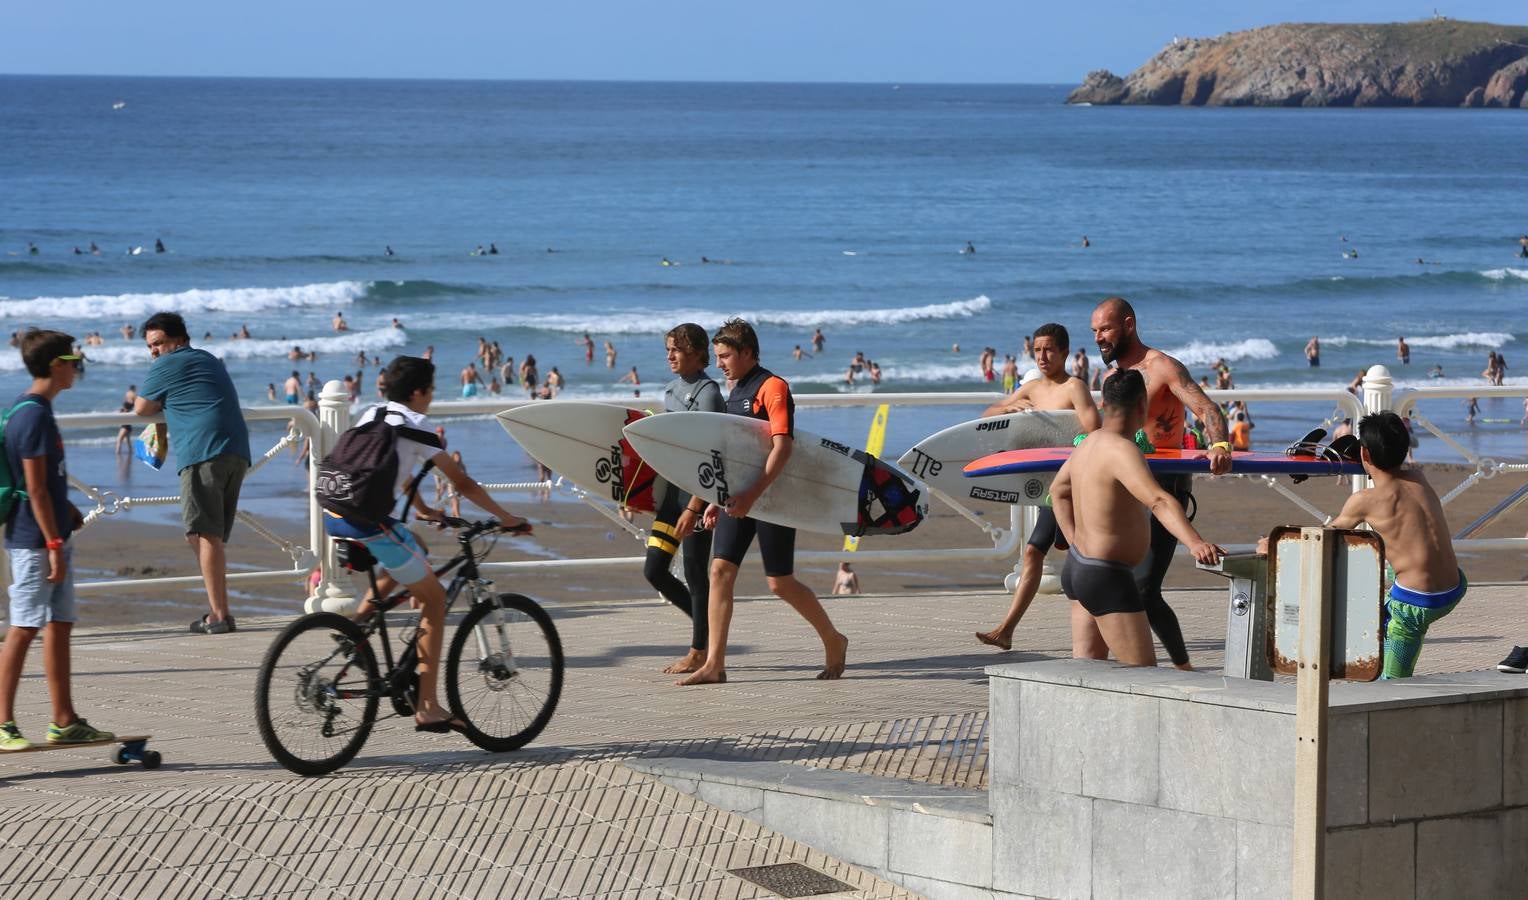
top-left (976, 322), bottom-right (1099, 649)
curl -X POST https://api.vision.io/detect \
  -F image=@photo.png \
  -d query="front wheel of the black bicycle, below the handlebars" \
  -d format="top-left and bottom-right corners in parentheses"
top-left (446, 594), bottom-right (562, 753)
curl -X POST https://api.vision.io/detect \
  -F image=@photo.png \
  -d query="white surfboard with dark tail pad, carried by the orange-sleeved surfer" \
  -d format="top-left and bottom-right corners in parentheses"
top-left (625, 413), bottom-right (929, 535)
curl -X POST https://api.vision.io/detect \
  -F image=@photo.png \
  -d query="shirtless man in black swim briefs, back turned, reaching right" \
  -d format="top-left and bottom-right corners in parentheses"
top-left (1051, 368), bottom-right (1224, 666)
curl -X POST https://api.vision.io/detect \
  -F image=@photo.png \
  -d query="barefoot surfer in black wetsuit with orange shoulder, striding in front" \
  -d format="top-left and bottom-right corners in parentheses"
top-left (678, 319), bottom-right (850, 685)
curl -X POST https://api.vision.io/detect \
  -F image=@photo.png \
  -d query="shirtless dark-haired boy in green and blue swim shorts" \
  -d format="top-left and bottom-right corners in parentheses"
top-left (1331, 413), bottom-right (1468, 678)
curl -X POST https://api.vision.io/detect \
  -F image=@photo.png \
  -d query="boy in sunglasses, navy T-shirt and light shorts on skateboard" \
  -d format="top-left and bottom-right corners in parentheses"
top-left (0, 330), bottom-right (113, 750)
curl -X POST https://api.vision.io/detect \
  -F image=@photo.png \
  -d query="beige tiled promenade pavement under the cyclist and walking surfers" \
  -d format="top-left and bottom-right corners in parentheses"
top-left (0, 584), bottom-right (1528, 898)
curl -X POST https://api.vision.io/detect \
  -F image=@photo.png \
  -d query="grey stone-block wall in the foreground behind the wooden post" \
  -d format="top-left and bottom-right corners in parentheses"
top-left (987, 660), bottom-right (1528, 900)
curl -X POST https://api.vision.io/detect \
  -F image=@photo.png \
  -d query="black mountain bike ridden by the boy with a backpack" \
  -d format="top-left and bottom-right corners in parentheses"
top-left (255, 516), bottom-right (562, 775)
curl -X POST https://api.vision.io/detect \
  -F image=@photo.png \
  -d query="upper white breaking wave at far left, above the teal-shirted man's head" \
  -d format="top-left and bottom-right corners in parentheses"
top-left (0, 281), bottom-right (367, 322)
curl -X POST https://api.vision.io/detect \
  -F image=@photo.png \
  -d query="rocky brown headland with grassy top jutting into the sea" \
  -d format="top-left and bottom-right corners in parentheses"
top-left (1067, 20), bottom-right (1528, 107)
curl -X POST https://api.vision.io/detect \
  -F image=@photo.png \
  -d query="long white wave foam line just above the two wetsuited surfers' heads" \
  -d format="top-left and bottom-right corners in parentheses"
top-left (437, 295), bottom-right (992, 335)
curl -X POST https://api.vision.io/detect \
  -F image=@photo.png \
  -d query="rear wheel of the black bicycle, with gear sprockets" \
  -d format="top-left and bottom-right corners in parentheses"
top-left (255, 613), bottom-right (377, 775)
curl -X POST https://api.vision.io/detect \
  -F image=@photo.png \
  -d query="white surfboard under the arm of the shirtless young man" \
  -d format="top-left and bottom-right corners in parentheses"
top-left (897, 410), bottom-right (1082, 506)
